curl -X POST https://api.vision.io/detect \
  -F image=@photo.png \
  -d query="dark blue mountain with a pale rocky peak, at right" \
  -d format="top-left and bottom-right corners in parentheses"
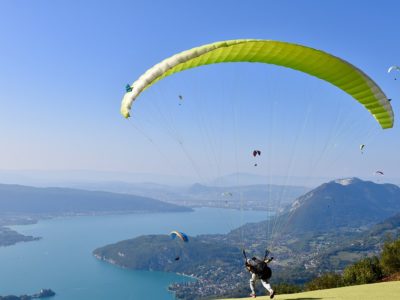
top-left (281, 178), bottom-right (400, 232)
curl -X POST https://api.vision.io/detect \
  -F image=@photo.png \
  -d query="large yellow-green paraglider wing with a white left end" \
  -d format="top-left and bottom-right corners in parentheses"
top-left (121, 40), bottom-right (394, 128)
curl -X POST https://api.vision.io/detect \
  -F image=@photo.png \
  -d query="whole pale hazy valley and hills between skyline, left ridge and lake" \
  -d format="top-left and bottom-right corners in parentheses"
top-left (0, 170), bottom-right (310, 211)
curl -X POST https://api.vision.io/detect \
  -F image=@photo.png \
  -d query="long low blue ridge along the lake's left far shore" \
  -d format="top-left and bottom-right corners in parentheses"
top-left (0, 184), bottom-right (190, 215)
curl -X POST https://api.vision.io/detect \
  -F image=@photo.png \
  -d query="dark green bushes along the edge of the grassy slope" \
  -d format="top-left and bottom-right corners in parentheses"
top-left (304, 239), bottom-right (400, 291)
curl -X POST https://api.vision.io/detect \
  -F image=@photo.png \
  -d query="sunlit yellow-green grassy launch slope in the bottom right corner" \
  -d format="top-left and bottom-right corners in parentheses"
top-left (222, 281), bottom-right (400, 300)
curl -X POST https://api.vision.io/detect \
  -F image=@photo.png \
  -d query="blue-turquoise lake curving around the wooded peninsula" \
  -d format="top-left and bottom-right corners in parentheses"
top-left (0, 208), bottom-right (267, 300)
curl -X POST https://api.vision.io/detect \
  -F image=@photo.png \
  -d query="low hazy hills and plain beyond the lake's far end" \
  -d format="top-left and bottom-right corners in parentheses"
top-left (65, 182), bottom-right (309, 210)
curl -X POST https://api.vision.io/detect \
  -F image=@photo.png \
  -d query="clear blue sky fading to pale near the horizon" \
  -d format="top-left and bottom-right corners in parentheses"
top-left (0, 0), bottom-right (400, 183)
